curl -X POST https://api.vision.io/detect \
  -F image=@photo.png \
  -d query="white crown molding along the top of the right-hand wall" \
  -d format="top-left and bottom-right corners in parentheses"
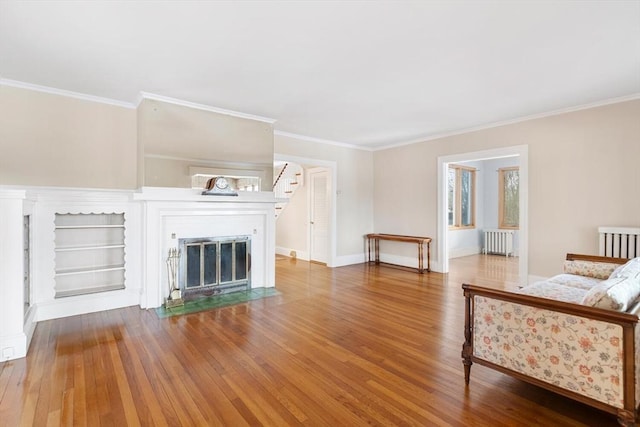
top-left (372, 92), bottom-right (640, 151)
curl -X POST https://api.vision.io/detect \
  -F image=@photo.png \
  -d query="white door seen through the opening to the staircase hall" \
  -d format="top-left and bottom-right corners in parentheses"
top-left (309, 168), bottom-right (329, 264)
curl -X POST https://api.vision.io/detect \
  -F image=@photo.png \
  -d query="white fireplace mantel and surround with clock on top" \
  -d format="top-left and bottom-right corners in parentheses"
top-left (134, 187), bottom-right (278, 308)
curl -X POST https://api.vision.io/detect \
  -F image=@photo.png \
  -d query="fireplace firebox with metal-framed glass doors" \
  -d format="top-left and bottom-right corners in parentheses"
top-left (178, 236), bottom-right (251, 299)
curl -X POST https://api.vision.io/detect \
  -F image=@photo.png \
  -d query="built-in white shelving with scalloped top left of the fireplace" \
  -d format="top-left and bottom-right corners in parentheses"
top-left (55, 213), bottom-right (125, 298)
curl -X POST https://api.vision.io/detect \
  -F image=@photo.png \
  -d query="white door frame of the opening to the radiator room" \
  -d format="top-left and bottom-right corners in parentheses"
top-left (436, 145), bottom-right (529, 285)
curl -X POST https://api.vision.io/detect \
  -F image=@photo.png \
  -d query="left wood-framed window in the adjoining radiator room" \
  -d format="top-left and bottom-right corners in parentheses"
top-left (447, 165), bottom-right (476, 229)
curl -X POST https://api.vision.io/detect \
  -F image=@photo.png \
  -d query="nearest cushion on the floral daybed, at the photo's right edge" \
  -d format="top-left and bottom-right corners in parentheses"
top-left (582, 272), bottom-right (640, 311)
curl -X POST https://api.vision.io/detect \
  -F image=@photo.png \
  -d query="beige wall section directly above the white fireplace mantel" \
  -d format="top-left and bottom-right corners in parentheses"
top-left (138, 99), bottom-right (273, 191)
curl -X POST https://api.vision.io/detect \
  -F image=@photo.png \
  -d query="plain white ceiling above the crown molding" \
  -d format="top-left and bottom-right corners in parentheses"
top-left (0, 0), bottom-right (640, 148)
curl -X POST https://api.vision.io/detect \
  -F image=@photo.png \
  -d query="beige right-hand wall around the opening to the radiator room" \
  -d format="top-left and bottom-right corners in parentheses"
top-left (374, 100), bottom-right (640, 276)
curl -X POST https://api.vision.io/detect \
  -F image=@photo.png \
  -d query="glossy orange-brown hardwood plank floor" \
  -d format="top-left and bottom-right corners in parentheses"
top-left (0, 256), bottom-right (616, 426)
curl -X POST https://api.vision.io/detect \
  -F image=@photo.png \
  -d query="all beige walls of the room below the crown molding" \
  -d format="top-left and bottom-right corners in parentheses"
top-left (0, 85), bottom-right (640, 276)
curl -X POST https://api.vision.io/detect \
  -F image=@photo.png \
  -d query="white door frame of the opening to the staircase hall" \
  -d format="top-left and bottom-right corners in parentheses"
top-left (273, 153), bottom-right (338, 267)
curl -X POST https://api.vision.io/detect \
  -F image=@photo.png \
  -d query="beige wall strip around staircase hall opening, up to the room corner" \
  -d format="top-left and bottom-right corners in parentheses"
top-left (275, 134), bottom-right (373, 264)
